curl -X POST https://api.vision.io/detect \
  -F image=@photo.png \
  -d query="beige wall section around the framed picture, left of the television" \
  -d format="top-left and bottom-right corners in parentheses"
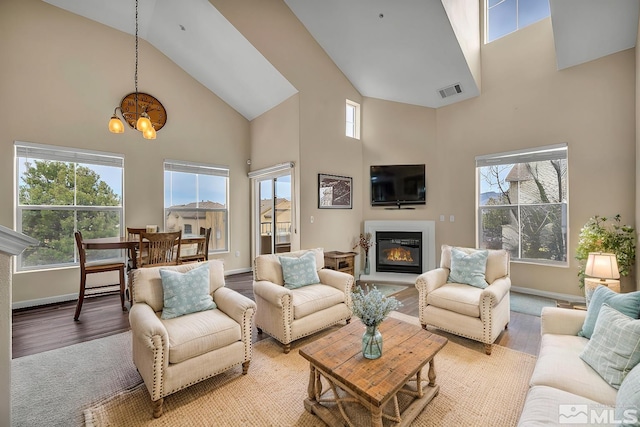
top-left (210, 0), bottom-right (363, 251)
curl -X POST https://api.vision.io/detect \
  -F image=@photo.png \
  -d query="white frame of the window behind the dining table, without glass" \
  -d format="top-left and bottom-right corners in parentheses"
top-left (163, 159), bottom-right (231, 254)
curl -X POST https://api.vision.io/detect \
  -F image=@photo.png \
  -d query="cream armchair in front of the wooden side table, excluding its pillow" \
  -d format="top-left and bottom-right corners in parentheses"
top-left (253, 249), bottom-right (354, 353)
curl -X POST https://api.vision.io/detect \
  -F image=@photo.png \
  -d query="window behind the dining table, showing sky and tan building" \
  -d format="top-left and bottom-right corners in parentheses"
top-left (164, 160), bottom-right (229, 252)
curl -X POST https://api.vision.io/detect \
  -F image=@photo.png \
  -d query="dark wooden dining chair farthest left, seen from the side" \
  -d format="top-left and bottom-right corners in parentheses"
top-left (73, 231), bottom-right (127, 320)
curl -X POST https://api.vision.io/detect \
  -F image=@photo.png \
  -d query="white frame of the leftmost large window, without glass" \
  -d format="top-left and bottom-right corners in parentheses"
top-left (14, 141), bottom-right (124, 272)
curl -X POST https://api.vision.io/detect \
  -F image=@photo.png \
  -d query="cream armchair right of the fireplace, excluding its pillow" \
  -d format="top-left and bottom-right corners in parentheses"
top-left (416, 245), bottom-right (511, 354)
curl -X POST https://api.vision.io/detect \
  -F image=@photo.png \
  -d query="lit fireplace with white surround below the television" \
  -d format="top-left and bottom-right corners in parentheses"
top-left (359, 220), bottom-right (436, 285)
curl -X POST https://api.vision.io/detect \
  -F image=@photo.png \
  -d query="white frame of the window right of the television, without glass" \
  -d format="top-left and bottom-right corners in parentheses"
top-left (475, 143), bottom-right (570, 267)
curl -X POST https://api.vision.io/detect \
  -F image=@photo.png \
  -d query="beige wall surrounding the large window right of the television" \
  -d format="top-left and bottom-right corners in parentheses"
top-left (438, 19), bottom-right (636, 295)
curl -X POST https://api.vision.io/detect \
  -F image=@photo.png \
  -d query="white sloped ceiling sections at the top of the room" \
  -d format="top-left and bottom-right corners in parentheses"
top-left (43, 0), bottom-right (639, 120)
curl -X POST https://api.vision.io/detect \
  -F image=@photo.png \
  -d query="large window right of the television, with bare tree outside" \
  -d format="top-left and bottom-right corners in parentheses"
top-left (476, 144), bottom-right (568, 265)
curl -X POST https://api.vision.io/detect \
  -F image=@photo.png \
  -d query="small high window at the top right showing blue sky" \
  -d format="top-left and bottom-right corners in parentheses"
top-left (485, 0), bottom-right (551, 43)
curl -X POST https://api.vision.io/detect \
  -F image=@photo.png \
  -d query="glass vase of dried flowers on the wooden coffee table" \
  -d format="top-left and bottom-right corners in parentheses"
top-left (351, 286), bottom-right (402, 359)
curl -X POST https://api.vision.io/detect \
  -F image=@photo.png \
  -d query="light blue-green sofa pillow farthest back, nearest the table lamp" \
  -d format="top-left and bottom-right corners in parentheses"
top-left (578, 286), bottom-right (640, 338)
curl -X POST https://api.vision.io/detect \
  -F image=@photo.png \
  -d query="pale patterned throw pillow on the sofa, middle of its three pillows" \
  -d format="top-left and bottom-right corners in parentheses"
top-left (580, 304), bottom-right (640, 389)
